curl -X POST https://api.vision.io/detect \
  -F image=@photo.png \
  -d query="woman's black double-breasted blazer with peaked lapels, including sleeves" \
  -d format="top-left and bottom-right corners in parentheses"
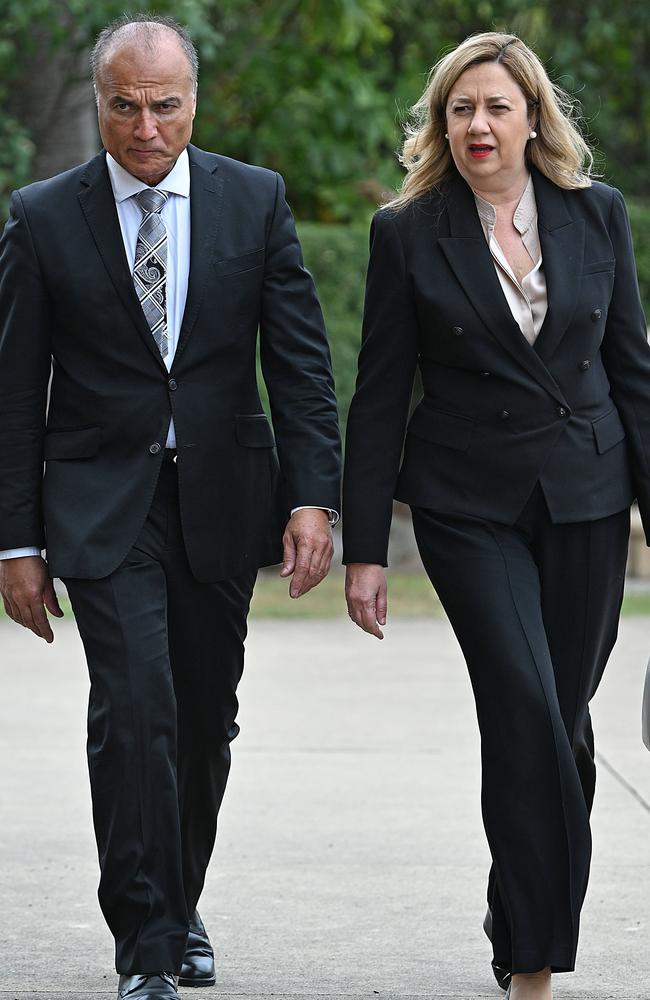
top-left (343, 170), bottom-right (650, 565)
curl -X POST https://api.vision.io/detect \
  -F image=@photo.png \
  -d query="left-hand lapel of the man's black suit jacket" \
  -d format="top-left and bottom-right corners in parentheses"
top-left (79, 152), bottom-right (165, 368)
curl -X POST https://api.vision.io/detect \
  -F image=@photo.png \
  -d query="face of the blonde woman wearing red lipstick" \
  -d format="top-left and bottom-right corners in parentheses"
top-left (446, 62), bottom-right (534, 193)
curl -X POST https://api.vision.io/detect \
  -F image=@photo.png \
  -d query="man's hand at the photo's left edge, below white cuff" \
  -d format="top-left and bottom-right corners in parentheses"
top-left (0, 556), bottom-right (63, 642)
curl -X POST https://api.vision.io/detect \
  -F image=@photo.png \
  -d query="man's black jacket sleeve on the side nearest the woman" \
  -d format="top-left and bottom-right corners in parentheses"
top-left (260, 174), bottom-right (341, 510)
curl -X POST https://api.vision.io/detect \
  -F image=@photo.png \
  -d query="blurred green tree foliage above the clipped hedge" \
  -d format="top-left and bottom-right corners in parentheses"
top-left (0, 0), bottom-right (650, 222)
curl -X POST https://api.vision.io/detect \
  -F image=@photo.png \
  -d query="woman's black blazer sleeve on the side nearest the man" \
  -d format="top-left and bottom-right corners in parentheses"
top-left (343, 210), bottom-right (419, 566)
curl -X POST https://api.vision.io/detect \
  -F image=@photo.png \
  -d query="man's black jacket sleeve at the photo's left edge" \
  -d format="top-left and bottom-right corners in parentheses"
top-left (0, 192), bottom-right (51, 549)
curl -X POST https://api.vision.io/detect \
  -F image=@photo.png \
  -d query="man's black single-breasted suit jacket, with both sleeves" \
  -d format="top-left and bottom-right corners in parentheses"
top-left (0, 146), bottom-right (339, 581)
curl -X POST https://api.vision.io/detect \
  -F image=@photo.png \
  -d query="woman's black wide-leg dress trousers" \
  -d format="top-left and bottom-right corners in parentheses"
top-left (412, 486), bottom-right (629, 973)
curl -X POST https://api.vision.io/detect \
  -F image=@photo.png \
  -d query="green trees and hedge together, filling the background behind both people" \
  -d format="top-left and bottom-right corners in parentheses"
top-left (0, 0), bottom-right (650, 430)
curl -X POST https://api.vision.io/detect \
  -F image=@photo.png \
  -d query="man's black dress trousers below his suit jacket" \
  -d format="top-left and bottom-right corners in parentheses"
top-left (64, 460), bottom-right (256, 973)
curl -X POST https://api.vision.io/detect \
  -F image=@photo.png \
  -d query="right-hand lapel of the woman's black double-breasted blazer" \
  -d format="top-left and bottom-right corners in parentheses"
top-left (533, 171), bottom-right (585, 364)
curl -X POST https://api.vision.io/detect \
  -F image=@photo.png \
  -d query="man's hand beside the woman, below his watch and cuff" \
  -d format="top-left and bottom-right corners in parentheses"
top-left (280, 507), bottom-right (334, 597)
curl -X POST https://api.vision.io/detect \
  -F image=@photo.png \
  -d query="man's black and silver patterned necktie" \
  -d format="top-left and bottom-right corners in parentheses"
top-left (133, 188), bottom-right (169, 358)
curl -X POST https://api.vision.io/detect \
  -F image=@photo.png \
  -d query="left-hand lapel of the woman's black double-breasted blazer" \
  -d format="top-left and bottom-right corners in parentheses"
top-left (438, 178), bottom-right (563, 401)
